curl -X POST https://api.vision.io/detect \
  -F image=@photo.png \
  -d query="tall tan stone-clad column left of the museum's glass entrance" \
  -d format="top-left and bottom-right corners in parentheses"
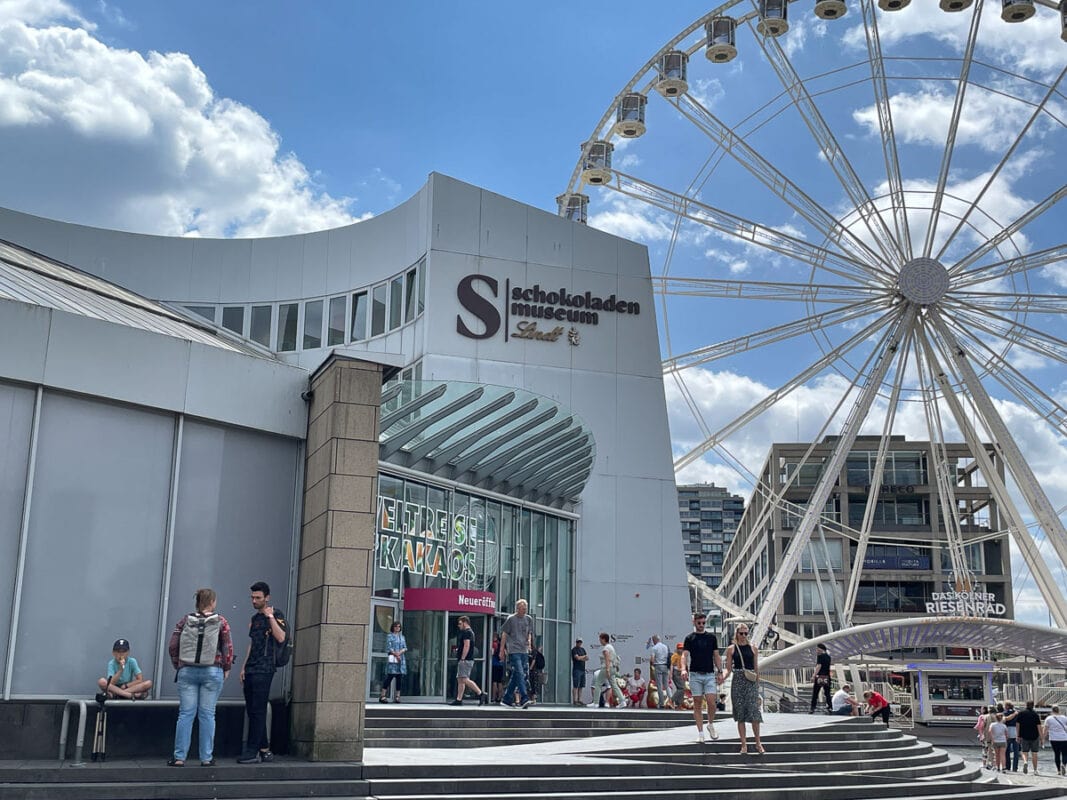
top-left (290, 355), bottom-right (382, 761)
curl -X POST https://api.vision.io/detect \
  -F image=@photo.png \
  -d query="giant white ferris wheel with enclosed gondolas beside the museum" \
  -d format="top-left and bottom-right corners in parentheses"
top-left (557, 0), bottom-right (1067, 630)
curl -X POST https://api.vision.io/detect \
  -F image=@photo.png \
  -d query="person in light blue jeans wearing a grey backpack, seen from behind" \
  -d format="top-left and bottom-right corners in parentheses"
top-left (166, 589), bottom-right (234, 767)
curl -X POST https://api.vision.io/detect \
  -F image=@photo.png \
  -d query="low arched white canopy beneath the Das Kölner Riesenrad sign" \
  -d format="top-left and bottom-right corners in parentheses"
top-left (760, 617), bottom-right (1067, 670)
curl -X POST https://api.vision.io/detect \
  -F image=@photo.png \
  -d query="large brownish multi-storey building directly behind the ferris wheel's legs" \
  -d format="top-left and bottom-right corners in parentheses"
top-left (717, 436), bottom-right (1014, 657)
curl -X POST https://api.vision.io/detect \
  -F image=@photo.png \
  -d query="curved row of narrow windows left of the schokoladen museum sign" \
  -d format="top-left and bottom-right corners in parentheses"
top-left (186, 259), bottom-right (426, 353)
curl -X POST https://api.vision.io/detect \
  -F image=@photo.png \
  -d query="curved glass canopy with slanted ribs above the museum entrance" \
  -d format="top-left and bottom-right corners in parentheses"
top-left (379, 381), bottom-right (596, 508)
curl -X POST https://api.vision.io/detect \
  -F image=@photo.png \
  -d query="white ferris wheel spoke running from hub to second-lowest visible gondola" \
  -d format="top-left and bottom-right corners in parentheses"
top-left (609, 171), bottom-right (873, 285)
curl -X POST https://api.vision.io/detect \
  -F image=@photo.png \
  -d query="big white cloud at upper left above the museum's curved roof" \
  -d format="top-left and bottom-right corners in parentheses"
top-left (0, 9), bottom-right (371, 236)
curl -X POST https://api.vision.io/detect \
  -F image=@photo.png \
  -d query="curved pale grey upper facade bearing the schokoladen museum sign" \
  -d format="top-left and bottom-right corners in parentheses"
top-left (0, 175), bottom-right (689, 678)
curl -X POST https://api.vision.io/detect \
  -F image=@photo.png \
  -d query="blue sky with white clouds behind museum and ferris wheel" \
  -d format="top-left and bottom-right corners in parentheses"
top-left (0, 0), bottom-right (1067, 619)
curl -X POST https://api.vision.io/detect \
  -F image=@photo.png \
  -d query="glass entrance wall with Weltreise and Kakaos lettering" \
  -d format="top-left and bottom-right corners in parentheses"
top-left (368, 473), bottom-right (575, 702)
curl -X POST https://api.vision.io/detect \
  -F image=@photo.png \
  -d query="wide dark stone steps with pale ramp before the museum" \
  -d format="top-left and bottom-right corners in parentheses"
top-left (0, 706), bottom-right (1067, 800)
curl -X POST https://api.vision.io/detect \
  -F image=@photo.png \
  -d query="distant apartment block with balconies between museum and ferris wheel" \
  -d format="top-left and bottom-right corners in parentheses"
top-left (678, 483), bottom-right (745, 589)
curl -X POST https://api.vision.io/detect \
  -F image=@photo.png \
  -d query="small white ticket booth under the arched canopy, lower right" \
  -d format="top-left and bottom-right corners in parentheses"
top-left (908, 661), bottom-right (993, 725)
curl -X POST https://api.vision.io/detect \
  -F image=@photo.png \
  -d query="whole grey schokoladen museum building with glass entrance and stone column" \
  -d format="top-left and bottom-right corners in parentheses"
top-left (0, 175), bottom-right (688, 758)
